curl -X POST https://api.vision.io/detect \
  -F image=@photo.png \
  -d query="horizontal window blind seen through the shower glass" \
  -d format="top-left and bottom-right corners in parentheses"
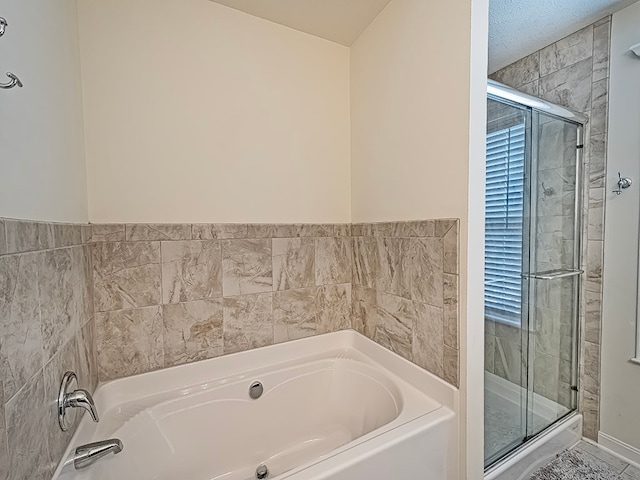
top-left (484, 124), bottom-right (525, 323)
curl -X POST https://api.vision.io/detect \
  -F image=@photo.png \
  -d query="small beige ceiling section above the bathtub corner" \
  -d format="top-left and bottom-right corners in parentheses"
top-left (212, 0), bottom-right (391, 47)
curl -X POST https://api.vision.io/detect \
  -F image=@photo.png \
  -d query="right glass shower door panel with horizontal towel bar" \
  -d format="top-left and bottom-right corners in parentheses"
top-left (527, 112), bottom-right (581, 437)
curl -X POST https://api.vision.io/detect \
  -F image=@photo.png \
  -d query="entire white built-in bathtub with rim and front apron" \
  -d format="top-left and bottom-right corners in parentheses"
top-left (53, 331), bottom-right (458, 480)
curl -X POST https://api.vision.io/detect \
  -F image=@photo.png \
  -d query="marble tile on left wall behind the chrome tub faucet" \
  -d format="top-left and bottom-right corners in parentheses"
top-left (0, 218), bottom-right (98, 480)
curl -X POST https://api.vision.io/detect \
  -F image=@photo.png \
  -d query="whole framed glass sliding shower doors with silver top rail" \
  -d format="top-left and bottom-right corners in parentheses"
top-left (484, 81), bottom-right (585, 467)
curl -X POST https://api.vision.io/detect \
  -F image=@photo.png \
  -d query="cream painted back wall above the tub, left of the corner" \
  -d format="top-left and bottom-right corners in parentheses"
top-left (78, 0), bottom-right (350, 222)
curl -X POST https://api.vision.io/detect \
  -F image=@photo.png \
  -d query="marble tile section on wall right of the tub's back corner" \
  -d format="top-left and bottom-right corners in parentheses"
top-left (352, 219), bottom-right (459, 386)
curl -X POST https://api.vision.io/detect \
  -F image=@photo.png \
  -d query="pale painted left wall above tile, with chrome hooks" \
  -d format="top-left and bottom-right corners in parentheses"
top-left (0, 0), bottom-right (88, 222)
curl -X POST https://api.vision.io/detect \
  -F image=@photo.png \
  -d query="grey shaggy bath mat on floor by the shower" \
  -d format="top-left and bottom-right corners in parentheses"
top-left (530, 450), bottom-right (622, 480)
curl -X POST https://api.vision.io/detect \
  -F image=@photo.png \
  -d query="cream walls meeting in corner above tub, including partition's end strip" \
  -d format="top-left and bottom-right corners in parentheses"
top-left (63, 0), bottom-right (487, 479)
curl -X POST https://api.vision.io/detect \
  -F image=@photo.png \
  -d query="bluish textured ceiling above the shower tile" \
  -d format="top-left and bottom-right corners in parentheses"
top-left (489, 0), bottom-right (637, 73)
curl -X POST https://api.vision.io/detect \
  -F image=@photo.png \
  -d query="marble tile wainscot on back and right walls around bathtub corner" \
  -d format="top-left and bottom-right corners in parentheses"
top-left (92, 220), bottom-right (458, 385)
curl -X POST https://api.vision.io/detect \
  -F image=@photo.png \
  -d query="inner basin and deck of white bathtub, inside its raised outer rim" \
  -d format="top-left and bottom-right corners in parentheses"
top-left (54, 332), bottom-right (456, 480)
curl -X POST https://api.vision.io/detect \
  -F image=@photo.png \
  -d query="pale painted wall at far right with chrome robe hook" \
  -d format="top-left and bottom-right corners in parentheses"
top-left (599, 2), bottom-right (640, 462)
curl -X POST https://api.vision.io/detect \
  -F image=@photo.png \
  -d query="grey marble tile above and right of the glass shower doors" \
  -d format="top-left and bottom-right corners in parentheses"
top-left (489, 17), bottom-right (611, 440)
